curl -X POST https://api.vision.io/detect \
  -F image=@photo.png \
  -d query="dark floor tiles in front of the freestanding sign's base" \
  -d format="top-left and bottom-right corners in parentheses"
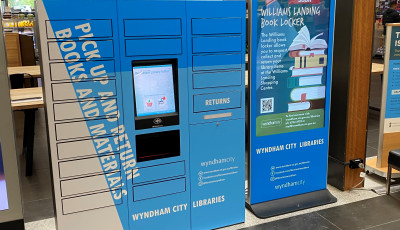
top-left (243, 193), bottom-right (400, 230)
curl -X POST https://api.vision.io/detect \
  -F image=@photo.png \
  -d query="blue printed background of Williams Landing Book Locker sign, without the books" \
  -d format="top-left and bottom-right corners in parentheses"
top-left (249, 0), bottom-right (335, 204)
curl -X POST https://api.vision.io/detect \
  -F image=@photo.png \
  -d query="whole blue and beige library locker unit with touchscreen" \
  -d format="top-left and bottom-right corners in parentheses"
top-left (37, 0), bottom-right (246, 230)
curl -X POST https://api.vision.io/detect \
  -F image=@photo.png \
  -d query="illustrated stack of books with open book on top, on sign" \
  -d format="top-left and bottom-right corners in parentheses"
top-left (288, 26), bottom-right (328, 112)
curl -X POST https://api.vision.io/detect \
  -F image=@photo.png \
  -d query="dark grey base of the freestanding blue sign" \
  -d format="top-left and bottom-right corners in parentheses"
top-left (246, 189), bottom-right (337, 219)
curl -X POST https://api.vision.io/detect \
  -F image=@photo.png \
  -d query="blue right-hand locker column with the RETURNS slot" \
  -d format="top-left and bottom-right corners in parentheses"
top-left (187, 1), bottom-right (246, 229)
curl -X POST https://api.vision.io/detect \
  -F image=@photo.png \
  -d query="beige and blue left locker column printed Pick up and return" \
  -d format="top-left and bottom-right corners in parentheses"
top-left (37, 0), bottom-right (128, 230)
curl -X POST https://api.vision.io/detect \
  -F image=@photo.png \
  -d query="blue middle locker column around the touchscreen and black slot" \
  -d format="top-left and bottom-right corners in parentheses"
top-left (117, 0), bottom-right (190, 230)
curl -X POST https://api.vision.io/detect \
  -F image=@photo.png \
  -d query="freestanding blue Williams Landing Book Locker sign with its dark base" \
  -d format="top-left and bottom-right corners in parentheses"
top-left (247, 0), bottom-right (335, 217)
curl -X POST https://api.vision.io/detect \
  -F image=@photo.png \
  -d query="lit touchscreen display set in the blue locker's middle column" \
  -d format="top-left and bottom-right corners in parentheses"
top-left (133, 64), bottom-right (176, 117)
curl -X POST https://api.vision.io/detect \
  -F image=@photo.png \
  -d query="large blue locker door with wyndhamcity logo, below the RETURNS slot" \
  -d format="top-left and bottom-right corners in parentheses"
top-left (190, 119), bottom-right (245, 229)
